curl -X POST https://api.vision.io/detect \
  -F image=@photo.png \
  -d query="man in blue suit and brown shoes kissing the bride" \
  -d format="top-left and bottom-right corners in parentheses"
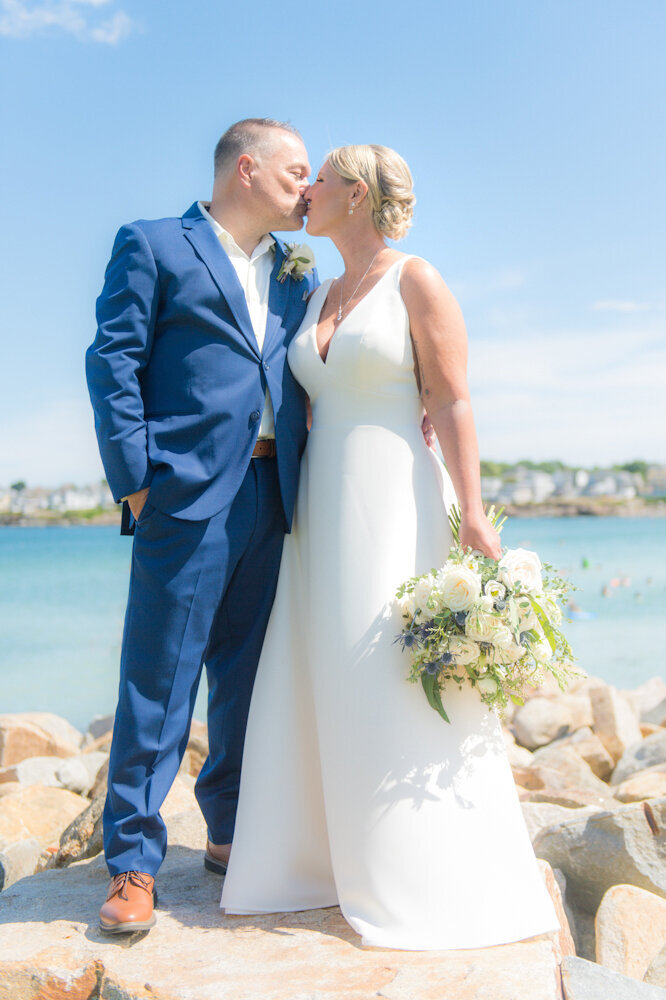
top-left (86, 119), bottom-right (316, 933)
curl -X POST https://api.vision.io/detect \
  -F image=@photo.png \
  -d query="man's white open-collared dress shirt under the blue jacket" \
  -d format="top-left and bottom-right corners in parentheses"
top-left (198, 201), bottom-right (275, 438)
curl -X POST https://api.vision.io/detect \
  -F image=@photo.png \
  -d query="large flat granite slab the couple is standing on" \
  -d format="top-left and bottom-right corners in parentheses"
top-left (0, 810), bottom-right (561, 1000)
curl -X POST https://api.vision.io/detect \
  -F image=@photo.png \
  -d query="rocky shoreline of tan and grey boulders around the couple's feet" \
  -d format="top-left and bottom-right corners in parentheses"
top-left (0, 677), bottom-right (666, 1000)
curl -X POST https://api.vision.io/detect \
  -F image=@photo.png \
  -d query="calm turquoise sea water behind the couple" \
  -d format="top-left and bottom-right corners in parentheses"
top-left (0, 517), bottom-right (666, 728)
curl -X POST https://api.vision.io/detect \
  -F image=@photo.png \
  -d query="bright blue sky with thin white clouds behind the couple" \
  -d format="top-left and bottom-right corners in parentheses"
top-left (0, 0), bottom-right (666, 485)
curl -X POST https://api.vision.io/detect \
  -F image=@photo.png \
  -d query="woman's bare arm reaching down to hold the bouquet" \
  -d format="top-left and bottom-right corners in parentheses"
top-left (400, 259), bottom-right (501, 559)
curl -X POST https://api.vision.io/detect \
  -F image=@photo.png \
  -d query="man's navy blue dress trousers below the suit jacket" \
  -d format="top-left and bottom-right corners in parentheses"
top-left (104, 458), bottom-right (284, 875)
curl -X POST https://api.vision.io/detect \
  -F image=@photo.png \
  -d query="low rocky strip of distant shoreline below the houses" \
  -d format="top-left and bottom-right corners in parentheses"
top-left (0, 497), bottom-right (666, 528)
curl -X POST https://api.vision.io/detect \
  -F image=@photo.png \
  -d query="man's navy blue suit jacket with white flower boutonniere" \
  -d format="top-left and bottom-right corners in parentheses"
top-left (86, 202), bottom-right (316, 530)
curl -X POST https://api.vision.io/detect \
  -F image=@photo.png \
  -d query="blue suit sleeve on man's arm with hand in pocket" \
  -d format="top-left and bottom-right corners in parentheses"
top-left (86, 223), bottom-right (159, 501)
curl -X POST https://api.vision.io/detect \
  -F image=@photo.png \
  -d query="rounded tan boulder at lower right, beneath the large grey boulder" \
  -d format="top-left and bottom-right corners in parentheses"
top-left (595, 885), bottom-right (666, 980)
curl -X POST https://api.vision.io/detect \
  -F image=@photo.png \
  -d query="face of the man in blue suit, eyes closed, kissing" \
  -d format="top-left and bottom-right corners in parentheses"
top-left (252, 129), bottom-right (311, 230)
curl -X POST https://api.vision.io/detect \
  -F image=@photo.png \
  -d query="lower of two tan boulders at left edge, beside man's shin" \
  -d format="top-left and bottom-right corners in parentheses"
top-left (0, 785), bottom-right (90, 847)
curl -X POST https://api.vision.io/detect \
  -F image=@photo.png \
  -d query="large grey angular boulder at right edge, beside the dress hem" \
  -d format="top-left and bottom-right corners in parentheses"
top-left (534, 798), bottom-right (666, 913)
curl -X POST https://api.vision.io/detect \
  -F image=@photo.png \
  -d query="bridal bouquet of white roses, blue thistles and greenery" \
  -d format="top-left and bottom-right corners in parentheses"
top-left (396, 507), bottom-right (577, 722)
